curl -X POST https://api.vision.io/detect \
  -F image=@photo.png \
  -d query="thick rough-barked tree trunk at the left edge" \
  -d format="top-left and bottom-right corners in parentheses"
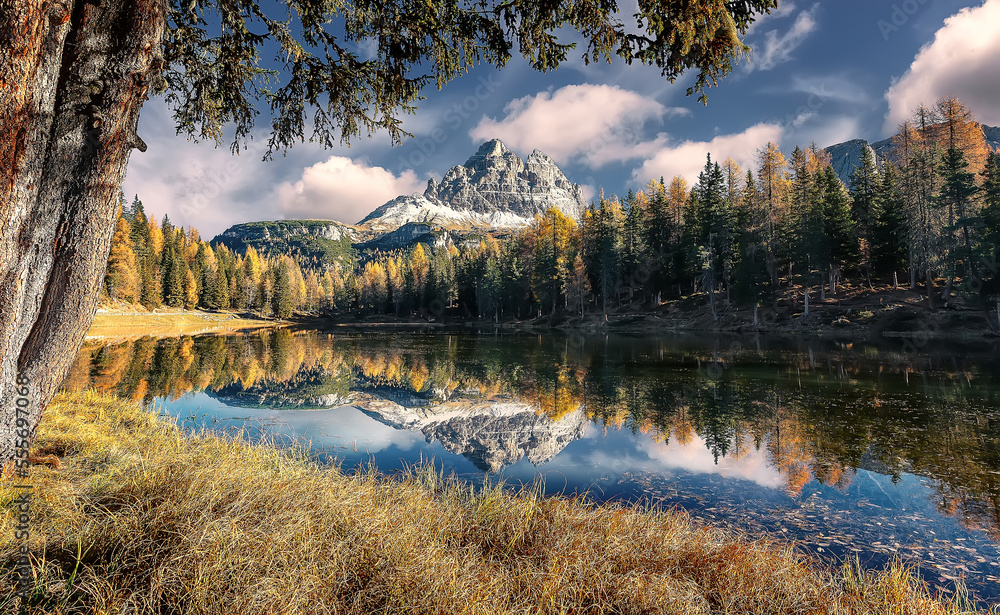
top-left (0, 0), bottom-right (165, 463)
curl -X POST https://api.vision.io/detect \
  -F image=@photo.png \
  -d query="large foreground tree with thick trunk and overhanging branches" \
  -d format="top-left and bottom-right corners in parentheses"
top-left (0, 0), bottom-right (777, 462)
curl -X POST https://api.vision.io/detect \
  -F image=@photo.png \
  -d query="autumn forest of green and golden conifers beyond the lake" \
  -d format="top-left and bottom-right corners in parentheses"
top-left (104, 98), bottom-right (1000, 322)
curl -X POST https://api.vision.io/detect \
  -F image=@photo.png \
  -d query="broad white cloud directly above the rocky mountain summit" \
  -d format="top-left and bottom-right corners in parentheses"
top-left (469, 84), bottom-right (690, 168)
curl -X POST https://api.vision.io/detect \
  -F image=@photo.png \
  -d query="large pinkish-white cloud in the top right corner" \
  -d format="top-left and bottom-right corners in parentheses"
top-left (884, 0), bottom-right (1000, 133)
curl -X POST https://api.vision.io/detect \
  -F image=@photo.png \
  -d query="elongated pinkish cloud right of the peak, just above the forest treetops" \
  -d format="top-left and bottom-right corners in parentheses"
top-left (632, 124), bottom-right (783, 185)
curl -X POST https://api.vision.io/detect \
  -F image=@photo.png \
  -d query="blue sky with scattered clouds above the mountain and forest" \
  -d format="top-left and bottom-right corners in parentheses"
top-left (123, 0), bottom-right (1000, 239)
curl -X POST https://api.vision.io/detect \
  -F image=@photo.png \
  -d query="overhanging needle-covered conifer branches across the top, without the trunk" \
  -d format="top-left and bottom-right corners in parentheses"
top-left (156, 0), bottom-right (777, 157)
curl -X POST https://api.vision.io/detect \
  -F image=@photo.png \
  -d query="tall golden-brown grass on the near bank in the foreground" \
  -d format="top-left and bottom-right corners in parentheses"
top-left (0, 392), bottom-right (984, 615)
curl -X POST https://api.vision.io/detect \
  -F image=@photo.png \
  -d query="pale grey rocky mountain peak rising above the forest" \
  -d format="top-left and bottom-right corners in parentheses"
top-left (360, 139), bottom-right (586, 230)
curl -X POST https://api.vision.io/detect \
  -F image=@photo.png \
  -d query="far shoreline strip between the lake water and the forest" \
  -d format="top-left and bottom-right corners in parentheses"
top-left (87, 287), bottom-right (1000, 342)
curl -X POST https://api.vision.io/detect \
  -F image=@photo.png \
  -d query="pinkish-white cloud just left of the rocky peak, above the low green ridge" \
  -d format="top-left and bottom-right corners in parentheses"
top-left (276, 156), bottom-right (423, 224)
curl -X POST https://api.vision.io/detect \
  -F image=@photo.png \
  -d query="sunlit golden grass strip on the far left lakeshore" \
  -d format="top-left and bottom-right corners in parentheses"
top-left (87, 310), bottom-right (280, 340)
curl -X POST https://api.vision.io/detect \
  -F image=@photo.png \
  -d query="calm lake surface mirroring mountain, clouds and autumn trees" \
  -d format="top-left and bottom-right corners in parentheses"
top-left (64, 330), bottom-right (1000, 604)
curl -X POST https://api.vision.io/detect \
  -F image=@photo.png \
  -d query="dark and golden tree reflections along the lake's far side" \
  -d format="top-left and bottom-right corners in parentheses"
top-left (64, 330), bottom-right (1000, 541)
